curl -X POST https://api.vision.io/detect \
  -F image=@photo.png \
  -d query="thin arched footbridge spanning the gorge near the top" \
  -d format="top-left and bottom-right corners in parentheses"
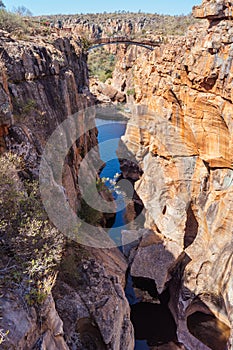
top-left (88, 37), bottom-right (161, 51)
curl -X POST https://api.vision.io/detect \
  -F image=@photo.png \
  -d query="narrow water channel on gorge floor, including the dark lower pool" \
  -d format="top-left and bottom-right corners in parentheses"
top-left (96, 114), bottom-right (180, 350)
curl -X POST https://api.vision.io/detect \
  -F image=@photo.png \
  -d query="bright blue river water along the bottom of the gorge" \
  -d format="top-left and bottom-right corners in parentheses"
top-left (96, 118), bottom-right (149, 350)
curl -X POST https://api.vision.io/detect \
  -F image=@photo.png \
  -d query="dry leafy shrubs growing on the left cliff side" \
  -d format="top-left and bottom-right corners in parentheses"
top-left (0, 153), bottom-right (63, 305)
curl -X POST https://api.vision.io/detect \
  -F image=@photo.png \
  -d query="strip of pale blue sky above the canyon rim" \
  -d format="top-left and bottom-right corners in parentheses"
top-left (3, 0), bottom-right (202, 15)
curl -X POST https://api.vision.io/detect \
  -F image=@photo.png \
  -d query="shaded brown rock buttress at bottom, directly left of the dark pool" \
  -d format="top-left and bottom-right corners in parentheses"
top-left (54, 250), bottom-right (134, 350)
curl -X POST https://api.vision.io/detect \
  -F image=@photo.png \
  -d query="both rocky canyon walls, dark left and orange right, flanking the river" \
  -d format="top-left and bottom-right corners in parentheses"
top-left (0, 0), bottom-right (233, 350)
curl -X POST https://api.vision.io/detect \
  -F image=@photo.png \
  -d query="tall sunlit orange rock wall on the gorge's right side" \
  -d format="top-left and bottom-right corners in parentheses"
top-left (116, 1), bottom-right (233, 349)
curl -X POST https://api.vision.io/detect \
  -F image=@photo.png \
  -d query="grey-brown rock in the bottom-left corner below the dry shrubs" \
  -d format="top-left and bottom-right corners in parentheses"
top-left (1, 292), bottom-right (69, 350)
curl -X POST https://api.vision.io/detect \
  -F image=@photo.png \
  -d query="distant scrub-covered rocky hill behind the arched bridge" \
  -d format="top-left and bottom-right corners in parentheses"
top-left (36, 11), bottom-right (197, 38)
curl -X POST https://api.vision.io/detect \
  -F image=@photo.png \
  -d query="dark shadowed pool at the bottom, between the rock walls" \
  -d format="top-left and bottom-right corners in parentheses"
top-left (126, 276), bottom-right (183, 350)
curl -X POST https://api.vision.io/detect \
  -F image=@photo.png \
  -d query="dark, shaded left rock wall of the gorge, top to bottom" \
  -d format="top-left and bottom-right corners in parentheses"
top-left (0, 32), bottom-right (134, 350)
